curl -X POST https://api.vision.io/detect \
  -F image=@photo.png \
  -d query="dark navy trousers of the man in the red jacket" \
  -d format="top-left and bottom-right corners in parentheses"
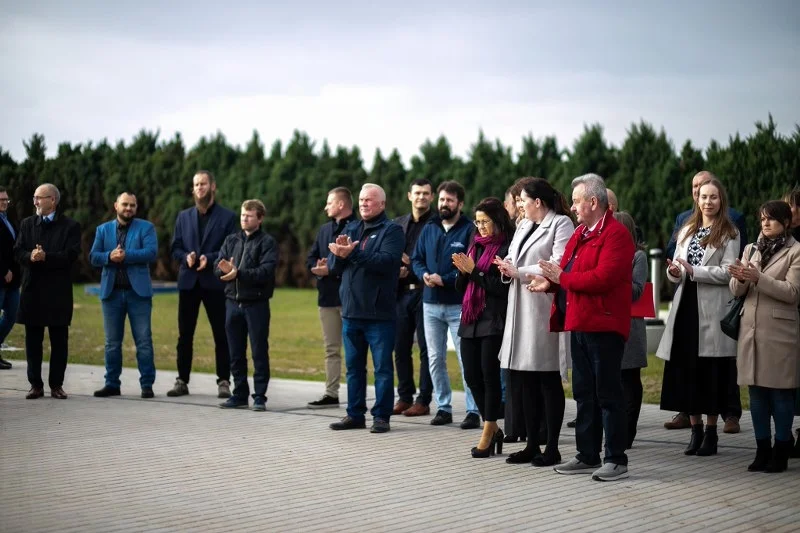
top-left (570, 331), bottom-right (628, 465)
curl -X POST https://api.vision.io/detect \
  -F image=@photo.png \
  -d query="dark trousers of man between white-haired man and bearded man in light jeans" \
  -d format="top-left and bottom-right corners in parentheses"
top-left (394, 290), bottom-right (433, 405)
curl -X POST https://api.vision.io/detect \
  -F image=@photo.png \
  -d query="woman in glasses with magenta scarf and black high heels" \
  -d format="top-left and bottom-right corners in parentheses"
top-left (453, 198), bottom-right (514, 458)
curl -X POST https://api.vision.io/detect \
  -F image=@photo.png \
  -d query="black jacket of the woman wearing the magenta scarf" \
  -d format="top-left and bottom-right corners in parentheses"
top-left (456, 242), bottom-right (510, 339)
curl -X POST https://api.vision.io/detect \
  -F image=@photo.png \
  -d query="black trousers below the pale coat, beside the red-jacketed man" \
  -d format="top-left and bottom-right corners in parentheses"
top-left (508, 370), bottom-right (565, 451)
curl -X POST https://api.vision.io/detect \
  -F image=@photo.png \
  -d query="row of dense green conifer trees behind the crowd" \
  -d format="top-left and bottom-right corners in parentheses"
top-left (0, 115), bottom-right (800, 286)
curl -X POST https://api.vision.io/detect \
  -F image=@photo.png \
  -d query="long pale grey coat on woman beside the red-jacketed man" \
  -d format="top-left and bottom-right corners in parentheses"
top-left (500, 211), bottom-right (575, 377)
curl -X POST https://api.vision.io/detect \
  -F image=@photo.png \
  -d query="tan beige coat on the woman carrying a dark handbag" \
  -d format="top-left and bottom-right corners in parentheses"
top-left (730, 238), bottom-right (800, 389)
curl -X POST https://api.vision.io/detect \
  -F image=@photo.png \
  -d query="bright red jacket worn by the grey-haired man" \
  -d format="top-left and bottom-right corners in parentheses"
top-left (550, 211), bottom-right (636, 341)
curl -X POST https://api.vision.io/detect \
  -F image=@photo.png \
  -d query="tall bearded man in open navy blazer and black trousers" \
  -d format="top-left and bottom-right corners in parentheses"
top-left (167, 170), bottom-right (237, 398)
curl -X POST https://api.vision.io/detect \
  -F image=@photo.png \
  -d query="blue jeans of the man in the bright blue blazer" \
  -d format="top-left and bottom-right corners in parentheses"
top-left (102, 289), bottom-right (156, 389)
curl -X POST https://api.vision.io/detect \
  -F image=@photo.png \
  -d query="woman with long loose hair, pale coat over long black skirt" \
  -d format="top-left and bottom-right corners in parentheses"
top-left (656, 178), bottom-right (739, 456)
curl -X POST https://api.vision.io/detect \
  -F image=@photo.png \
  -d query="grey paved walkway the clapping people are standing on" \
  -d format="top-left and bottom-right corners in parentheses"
top-left (0, 361), bottom-right (800, 533)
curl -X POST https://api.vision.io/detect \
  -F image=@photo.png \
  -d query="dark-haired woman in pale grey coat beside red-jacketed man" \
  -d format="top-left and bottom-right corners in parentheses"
top-left (496, 178), bottom-right (575, 466)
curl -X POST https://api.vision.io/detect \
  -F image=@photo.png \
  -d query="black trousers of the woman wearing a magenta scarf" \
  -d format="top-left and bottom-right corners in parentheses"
top-left (461, 335), bottom-right (503, 422)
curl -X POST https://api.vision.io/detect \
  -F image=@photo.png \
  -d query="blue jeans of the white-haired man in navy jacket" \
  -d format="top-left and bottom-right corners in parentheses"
top-left (342, 318), bottom-right (395, 422)
